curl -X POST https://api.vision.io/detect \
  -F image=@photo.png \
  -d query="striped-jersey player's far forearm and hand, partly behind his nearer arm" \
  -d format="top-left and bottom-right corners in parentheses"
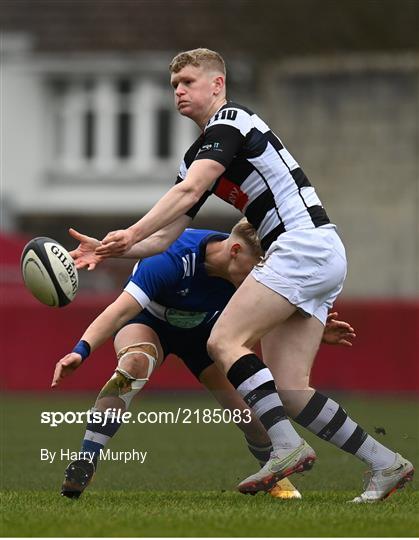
top-left (69, 215), bottom-right (192, 270)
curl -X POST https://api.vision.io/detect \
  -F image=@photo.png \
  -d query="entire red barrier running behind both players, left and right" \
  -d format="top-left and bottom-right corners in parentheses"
top-left (0, 285), bottom-right (419, 391)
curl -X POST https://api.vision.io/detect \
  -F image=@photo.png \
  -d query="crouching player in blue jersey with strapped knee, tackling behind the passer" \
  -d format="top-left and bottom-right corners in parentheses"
top-left (52, 219), bottom-right (354, 498)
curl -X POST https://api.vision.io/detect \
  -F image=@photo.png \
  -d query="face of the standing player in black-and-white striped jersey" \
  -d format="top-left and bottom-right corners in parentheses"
top-left (170, 66), bottom-right (219, 123)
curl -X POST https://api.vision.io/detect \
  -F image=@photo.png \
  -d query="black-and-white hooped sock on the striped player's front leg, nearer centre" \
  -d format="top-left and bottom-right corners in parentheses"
top-left (227, 354), bottom-right (301, 451)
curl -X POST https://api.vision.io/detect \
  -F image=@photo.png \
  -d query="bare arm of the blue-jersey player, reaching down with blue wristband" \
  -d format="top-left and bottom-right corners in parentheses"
top-left (51, 291), bottom-right (143, 387)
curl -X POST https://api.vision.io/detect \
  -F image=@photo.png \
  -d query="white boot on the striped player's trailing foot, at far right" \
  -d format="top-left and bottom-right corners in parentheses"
top-left (351, 454), bottom-right (415, 503)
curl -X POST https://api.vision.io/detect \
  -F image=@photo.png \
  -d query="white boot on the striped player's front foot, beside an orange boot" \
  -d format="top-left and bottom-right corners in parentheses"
top-left (237, 439), bottom-right (316, 495)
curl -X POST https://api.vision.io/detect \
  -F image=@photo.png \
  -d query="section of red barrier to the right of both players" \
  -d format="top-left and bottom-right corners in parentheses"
top-left (312, 300), bottom-right (419, 392)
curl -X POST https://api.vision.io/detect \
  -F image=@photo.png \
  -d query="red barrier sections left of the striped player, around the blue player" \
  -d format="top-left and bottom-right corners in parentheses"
top-left (0, 286), bottom-right (200, 391)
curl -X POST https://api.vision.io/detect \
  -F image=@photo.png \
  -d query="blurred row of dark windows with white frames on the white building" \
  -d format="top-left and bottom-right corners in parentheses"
top-left (50, 76), bottom-right (195, 176)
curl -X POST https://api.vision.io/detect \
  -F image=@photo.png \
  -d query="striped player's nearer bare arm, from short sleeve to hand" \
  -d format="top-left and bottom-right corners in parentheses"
top-left (96, 159), bottom-right (225, 257)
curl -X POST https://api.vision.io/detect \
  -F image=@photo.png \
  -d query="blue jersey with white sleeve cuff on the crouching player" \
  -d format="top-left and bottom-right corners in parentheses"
top-left (124, 229), bottom-right (236, 328)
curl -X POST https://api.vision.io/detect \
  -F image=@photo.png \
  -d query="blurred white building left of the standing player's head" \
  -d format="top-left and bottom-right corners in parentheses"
top-left (1, 34), bottom-right (197, 220)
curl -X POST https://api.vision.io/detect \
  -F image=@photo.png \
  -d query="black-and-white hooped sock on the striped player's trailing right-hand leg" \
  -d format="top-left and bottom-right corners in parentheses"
top-left (294, 392), bottom-right (396, 469)
